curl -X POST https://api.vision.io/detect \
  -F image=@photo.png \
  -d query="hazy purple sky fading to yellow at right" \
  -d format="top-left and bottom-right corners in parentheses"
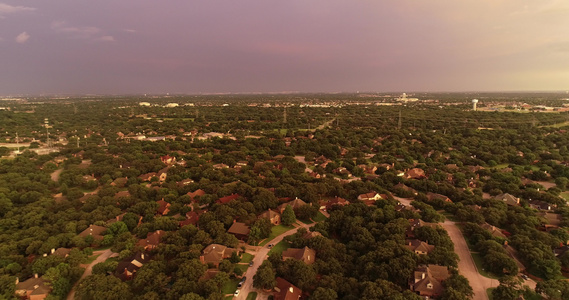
top-left (0, 0), bottom-right (569, 95)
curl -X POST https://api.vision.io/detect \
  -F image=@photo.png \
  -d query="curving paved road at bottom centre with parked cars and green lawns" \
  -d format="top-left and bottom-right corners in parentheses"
top-left (234, 222), bottom-right (314, 300)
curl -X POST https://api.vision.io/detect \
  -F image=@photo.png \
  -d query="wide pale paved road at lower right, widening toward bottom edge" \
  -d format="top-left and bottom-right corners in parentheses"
top-left (442, 220), bottom-right (500, 300)
